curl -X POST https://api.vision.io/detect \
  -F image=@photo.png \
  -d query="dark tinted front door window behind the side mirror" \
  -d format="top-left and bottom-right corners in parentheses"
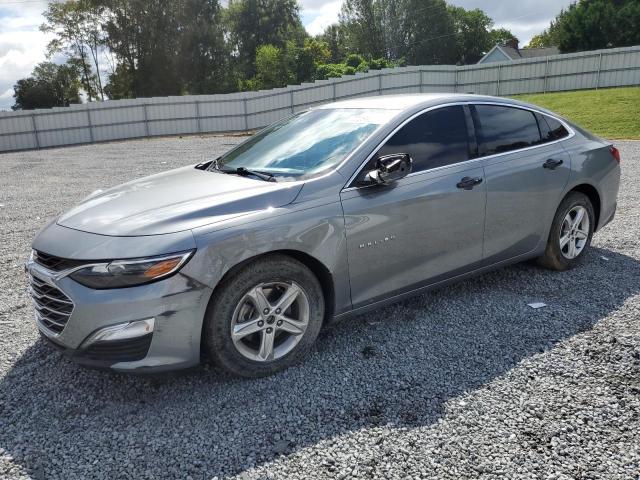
top-left (374, 106), bottom-right (469, 172)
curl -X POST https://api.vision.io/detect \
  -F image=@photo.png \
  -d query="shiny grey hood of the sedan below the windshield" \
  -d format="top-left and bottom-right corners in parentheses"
top-left (57, 167), bottom-right (302, 236)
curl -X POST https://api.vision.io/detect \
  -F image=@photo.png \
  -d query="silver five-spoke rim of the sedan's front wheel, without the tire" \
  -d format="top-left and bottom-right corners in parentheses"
top-left (231, 282), bottom-right (309, 362)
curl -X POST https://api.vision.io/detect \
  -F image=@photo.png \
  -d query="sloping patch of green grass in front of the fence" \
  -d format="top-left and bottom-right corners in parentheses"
top-left (514, 87), bottom-right (640, 140)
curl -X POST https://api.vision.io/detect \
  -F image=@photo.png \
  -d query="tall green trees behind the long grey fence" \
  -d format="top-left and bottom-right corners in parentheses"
top-left (13, 0), bottom-right (639, 109)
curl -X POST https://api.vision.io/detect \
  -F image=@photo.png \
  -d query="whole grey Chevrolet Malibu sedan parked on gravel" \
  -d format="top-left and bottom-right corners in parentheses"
top-left (27, 94), bottom-right (620, 377)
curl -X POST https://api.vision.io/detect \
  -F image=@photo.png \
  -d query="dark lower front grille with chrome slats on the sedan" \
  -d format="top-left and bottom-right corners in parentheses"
top-left (29, 276), bottom-right (73, 334)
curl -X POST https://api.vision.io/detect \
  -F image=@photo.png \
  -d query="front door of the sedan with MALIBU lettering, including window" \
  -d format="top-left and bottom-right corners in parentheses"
top-left (341, 106), bottom-right (486, 308)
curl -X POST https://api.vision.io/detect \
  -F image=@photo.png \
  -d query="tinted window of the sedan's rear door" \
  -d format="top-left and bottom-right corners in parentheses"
top-left (475, 105), bottom-right (541, 155)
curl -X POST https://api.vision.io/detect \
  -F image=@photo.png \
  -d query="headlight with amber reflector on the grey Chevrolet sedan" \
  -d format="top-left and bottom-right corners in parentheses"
top-left (69, 250), bottom-right (194, 289)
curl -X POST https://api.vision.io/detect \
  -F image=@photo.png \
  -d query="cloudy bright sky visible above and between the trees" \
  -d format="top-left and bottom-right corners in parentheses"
top-left (0, 0), bottom-right (572, 110)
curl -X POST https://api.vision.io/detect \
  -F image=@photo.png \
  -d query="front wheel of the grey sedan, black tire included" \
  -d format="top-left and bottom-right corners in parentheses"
top-left (203, 254), bottom-right (325, 378)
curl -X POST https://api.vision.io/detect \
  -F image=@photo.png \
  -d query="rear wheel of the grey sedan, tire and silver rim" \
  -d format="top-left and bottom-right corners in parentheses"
top-left (538, 192), bottom-right (596, 271)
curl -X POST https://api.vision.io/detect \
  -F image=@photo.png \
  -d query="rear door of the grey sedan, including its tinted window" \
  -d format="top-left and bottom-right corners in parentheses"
top-left (472, 104), bottom-right (571, 263)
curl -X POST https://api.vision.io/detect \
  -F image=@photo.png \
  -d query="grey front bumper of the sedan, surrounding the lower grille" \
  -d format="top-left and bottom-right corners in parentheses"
top-left (27, 260), bottom-right (212, 371)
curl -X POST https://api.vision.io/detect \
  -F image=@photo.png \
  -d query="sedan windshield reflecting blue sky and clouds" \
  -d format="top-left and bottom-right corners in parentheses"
top-left (210, 108), bottom-right (396, 180)
